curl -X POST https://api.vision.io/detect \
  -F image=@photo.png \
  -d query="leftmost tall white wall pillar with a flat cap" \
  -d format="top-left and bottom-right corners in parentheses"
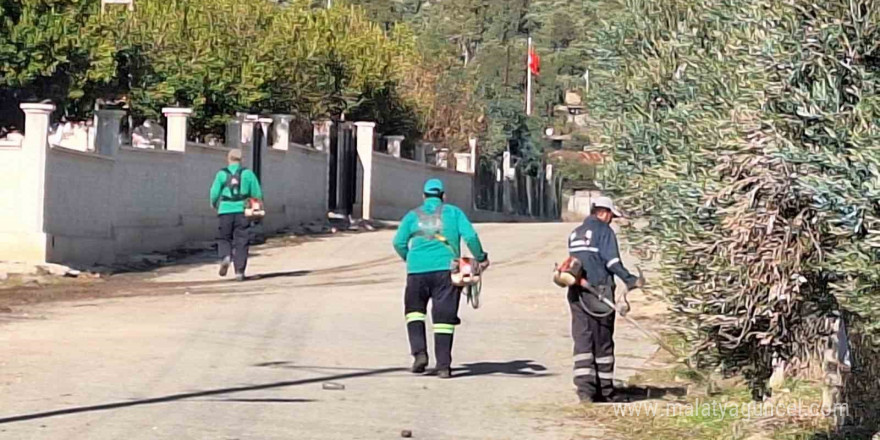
top-left (16, 104), bottom-right (55, 263)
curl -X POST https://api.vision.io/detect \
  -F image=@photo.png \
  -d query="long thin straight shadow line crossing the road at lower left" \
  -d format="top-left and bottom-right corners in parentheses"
top-left (0, 368), bottom-right (405, 425)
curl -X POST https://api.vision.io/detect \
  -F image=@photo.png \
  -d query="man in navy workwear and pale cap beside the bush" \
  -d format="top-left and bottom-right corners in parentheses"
top-left (568, 197), bottom-right (644, 402)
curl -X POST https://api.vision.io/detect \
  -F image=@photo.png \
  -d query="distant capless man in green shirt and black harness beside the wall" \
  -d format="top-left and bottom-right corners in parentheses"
top-left (211, 149), bottom-right (263, 281)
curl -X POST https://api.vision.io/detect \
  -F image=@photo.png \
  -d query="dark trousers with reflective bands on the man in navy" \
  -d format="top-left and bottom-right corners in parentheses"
top-left (569, 295), bottom-right (615, 398)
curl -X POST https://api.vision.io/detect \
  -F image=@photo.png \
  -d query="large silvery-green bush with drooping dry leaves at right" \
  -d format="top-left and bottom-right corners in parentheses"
top-left (585, 0), bottom-right (880, 395)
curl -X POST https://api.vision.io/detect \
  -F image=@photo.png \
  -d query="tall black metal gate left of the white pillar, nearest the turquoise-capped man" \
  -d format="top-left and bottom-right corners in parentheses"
top-left (329, 122), bottom-right (357, 215)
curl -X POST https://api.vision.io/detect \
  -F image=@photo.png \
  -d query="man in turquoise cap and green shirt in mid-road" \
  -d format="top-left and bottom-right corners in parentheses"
top-left (394, 179), bottom-right (489, 379)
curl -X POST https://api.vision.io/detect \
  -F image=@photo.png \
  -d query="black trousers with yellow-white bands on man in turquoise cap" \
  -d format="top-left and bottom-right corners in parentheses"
top-left (403, 270), bottom-right (461, 369)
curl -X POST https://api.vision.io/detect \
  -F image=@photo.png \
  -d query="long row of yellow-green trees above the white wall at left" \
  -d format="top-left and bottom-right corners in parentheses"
top-left (0, 0), bottom-right (419, 135)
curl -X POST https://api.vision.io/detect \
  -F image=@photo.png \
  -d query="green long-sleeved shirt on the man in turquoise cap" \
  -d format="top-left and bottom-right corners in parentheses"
top-left (394, 197), bottom-right (488, 274)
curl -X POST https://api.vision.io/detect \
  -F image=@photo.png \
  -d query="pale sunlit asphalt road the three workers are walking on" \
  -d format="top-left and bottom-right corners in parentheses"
top-left (0, 224), bottom-right (656, 440)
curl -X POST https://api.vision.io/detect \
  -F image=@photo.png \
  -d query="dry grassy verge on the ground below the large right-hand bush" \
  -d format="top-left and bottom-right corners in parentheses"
top-left (571, 366), bottom-right (831, 440)
